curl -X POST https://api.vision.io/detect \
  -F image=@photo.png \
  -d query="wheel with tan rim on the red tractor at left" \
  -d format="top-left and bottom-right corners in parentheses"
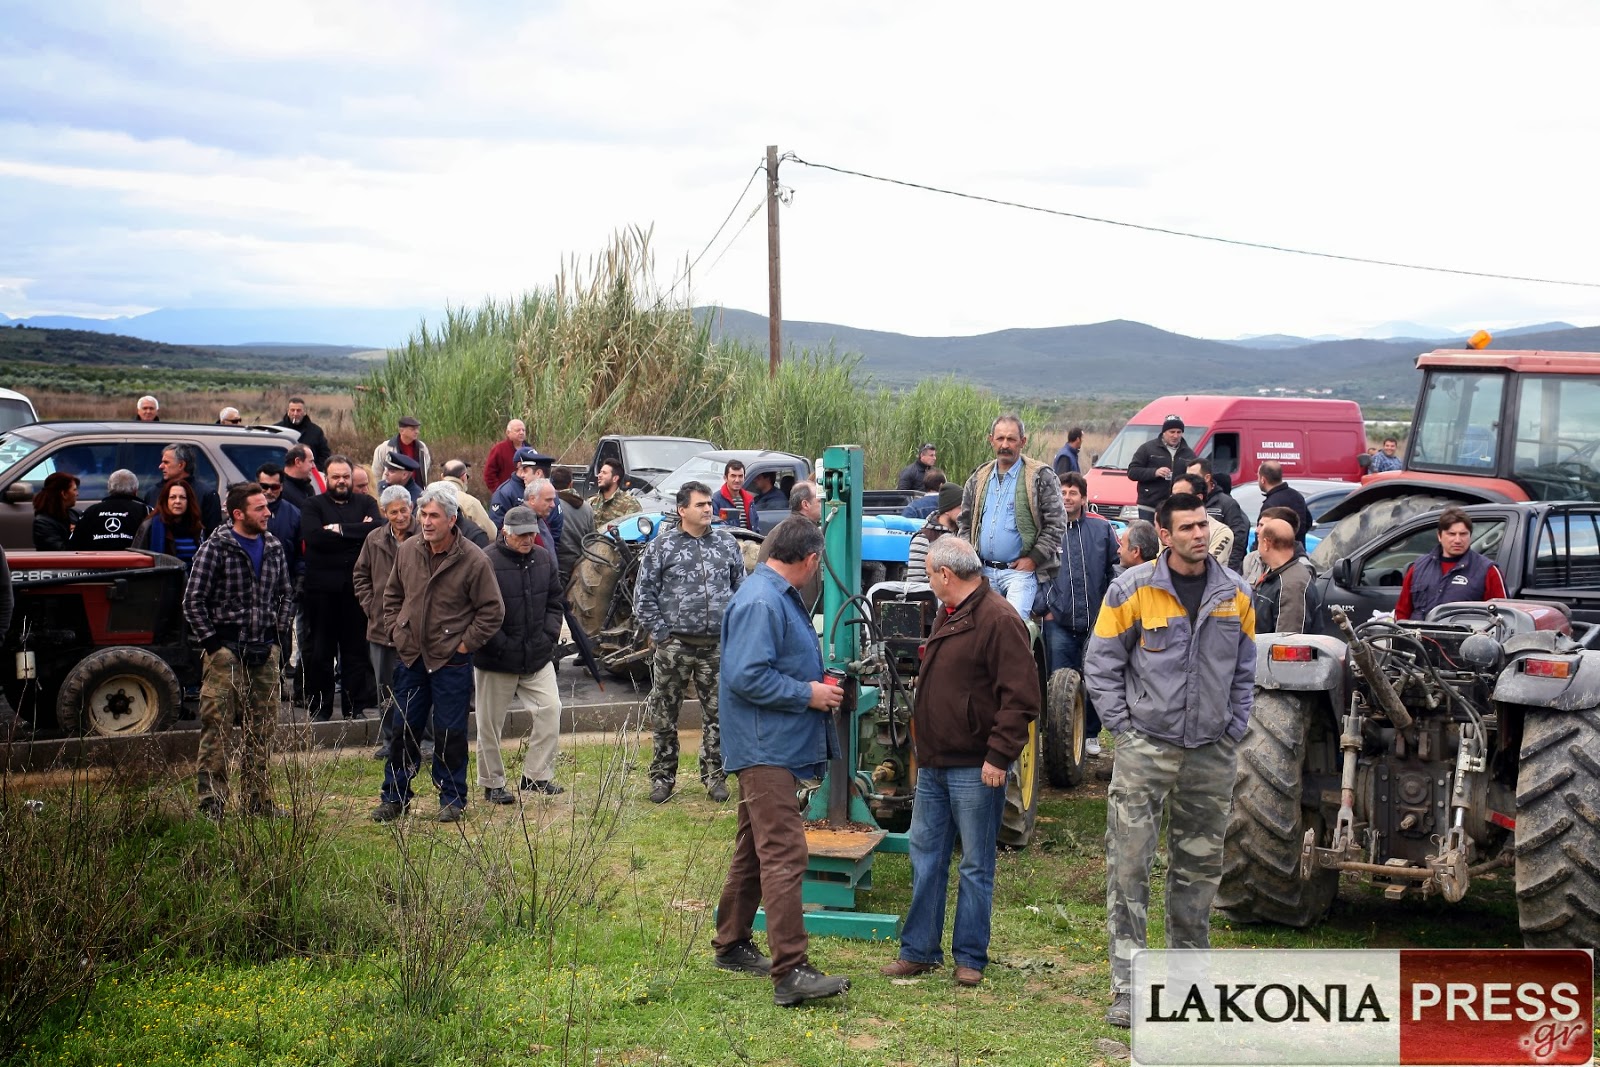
top-left (56, 646), bottom-right (182, 737)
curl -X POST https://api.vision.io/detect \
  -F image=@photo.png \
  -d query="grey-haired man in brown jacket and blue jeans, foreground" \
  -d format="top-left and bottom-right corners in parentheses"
top-left (883, 537), bottom-right (1040, 985)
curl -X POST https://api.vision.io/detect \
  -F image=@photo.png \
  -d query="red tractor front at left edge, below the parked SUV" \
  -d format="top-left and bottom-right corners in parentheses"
top-left (0, 552), bottom-right (200, 736)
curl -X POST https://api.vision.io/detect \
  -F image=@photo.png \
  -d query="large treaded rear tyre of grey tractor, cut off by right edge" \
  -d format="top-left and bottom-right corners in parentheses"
top-left (1517, 709), bottom-right (1600, 949)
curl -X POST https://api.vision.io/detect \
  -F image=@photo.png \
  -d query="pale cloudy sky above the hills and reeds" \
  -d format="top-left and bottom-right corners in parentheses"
top-left (0, 0), bottom-right (1600, 338)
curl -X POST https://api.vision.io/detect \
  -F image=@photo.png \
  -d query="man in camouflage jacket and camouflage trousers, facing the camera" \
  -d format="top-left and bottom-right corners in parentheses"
top-left (634, 482), bottom-right (744, 805)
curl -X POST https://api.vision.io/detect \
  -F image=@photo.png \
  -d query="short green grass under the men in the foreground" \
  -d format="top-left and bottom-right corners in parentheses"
top-left (0, 737), bottom-right (1517, 1067)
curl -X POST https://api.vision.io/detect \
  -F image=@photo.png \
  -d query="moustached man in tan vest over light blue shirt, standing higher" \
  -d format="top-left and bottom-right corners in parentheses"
top-left (958, 414), bottom-right (1067, 621)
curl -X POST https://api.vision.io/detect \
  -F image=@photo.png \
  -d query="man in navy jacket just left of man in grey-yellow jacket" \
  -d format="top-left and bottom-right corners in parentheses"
top-left (1034, 470), bottom-right (1117, 755)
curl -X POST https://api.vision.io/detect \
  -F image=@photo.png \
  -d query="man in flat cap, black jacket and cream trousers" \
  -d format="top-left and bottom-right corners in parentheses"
top-left (472, 507), bottom-right (566, 805)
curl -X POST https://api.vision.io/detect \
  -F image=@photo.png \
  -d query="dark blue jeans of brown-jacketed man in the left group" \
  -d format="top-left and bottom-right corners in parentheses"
top-left (382, 653), bottom-right (472, 808)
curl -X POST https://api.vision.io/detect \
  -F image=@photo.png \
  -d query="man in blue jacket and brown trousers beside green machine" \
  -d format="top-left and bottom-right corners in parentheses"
top-left (710, 517), bottom-right (850, 1008)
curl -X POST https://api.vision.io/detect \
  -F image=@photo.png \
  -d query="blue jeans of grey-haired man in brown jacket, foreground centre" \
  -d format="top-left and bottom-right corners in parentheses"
top-left (901, 766), bottom-right (1005, 971)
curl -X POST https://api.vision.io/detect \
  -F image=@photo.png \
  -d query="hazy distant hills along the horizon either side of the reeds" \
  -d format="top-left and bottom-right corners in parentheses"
top-left (0, 307), bottom-right (1600, 403)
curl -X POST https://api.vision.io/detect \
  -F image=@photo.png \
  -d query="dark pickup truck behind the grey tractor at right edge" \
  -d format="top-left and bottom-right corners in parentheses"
top-left (1310, 502), bottom-right (1600, 633)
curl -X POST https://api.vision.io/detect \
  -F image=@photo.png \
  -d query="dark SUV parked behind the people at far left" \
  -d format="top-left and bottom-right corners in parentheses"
top-left (0, 422), bottom-right (299, 549)
